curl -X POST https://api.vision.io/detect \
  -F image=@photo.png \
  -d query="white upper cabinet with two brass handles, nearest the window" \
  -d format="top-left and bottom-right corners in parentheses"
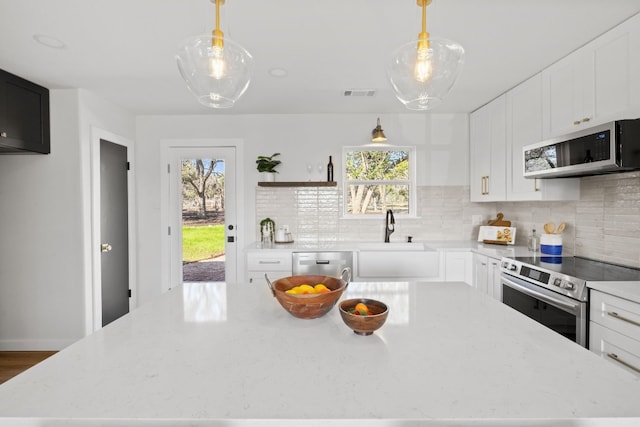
top-left (469, 95), bottom-right (506, 202)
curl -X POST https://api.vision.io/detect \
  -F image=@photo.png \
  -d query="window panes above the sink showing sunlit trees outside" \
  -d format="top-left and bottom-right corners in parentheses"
top-left (344, 146), bottom-right (415, 215)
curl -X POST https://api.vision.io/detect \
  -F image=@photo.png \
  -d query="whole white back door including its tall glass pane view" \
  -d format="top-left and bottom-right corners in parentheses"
top-left (165, 145), bottom-right (238, 290)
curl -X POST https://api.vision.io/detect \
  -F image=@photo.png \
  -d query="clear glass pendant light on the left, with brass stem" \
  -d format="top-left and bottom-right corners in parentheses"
top-left (176, 0), bottom-right (253, 108)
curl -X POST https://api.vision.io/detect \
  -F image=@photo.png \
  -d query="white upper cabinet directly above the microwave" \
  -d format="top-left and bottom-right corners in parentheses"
top-left (542, 15), bottom-right (640, 139)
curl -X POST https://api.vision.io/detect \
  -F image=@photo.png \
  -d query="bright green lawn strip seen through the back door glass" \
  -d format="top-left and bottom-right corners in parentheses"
top-left (182, 224), bottom-right (224, 262)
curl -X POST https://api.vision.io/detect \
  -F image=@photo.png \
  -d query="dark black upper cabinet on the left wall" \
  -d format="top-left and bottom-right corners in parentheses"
top-left (0, 70), bottom-right (51, 154)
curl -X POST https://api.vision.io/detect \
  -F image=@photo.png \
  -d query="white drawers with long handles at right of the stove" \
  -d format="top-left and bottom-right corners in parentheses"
top-left (589, 290), bottom-right (640, 376)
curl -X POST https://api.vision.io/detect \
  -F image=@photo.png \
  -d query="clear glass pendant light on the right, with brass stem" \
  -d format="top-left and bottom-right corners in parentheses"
top-left (387, 0), bottom-right (464, 110)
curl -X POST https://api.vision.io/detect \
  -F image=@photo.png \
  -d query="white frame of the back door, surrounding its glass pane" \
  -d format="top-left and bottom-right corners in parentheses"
top-left (167, 146), bottom-right (238, 288)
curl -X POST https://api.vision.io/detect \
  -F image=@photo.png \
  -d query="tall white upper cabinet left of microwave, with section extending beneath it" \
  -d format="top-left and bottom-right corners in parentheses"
top-left (506, 74), bottom-right (580, 201)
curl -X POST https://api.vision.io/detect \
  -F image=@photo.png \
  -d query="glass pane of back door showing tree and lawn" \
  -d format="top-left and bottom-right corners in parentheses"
top-left (180, 158), bottom-right (226, 282)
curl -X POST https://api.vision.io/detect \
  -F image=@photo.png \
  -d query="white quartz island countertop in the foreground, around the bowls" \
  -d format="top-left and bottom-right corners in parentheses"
top-left (0, 282), bottom-right (640, 427)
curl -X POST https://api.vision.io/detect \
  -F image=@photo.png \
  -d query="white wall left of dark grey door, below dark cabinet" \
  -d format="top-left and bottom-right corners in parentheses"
top-left (0, 90), bottom-right (135, 350)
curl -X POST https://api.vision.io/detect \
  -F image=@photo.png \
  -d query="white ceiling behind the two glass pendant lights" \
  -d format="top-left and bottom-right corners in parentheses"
top-left (0, 0), bottom-right (640, 114)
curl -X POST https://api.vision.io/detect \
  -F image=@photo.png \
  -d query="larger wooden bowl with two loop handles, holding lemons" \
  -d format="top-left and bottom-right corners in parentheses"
top-left (265, 268), bottom-right (351, 319)
